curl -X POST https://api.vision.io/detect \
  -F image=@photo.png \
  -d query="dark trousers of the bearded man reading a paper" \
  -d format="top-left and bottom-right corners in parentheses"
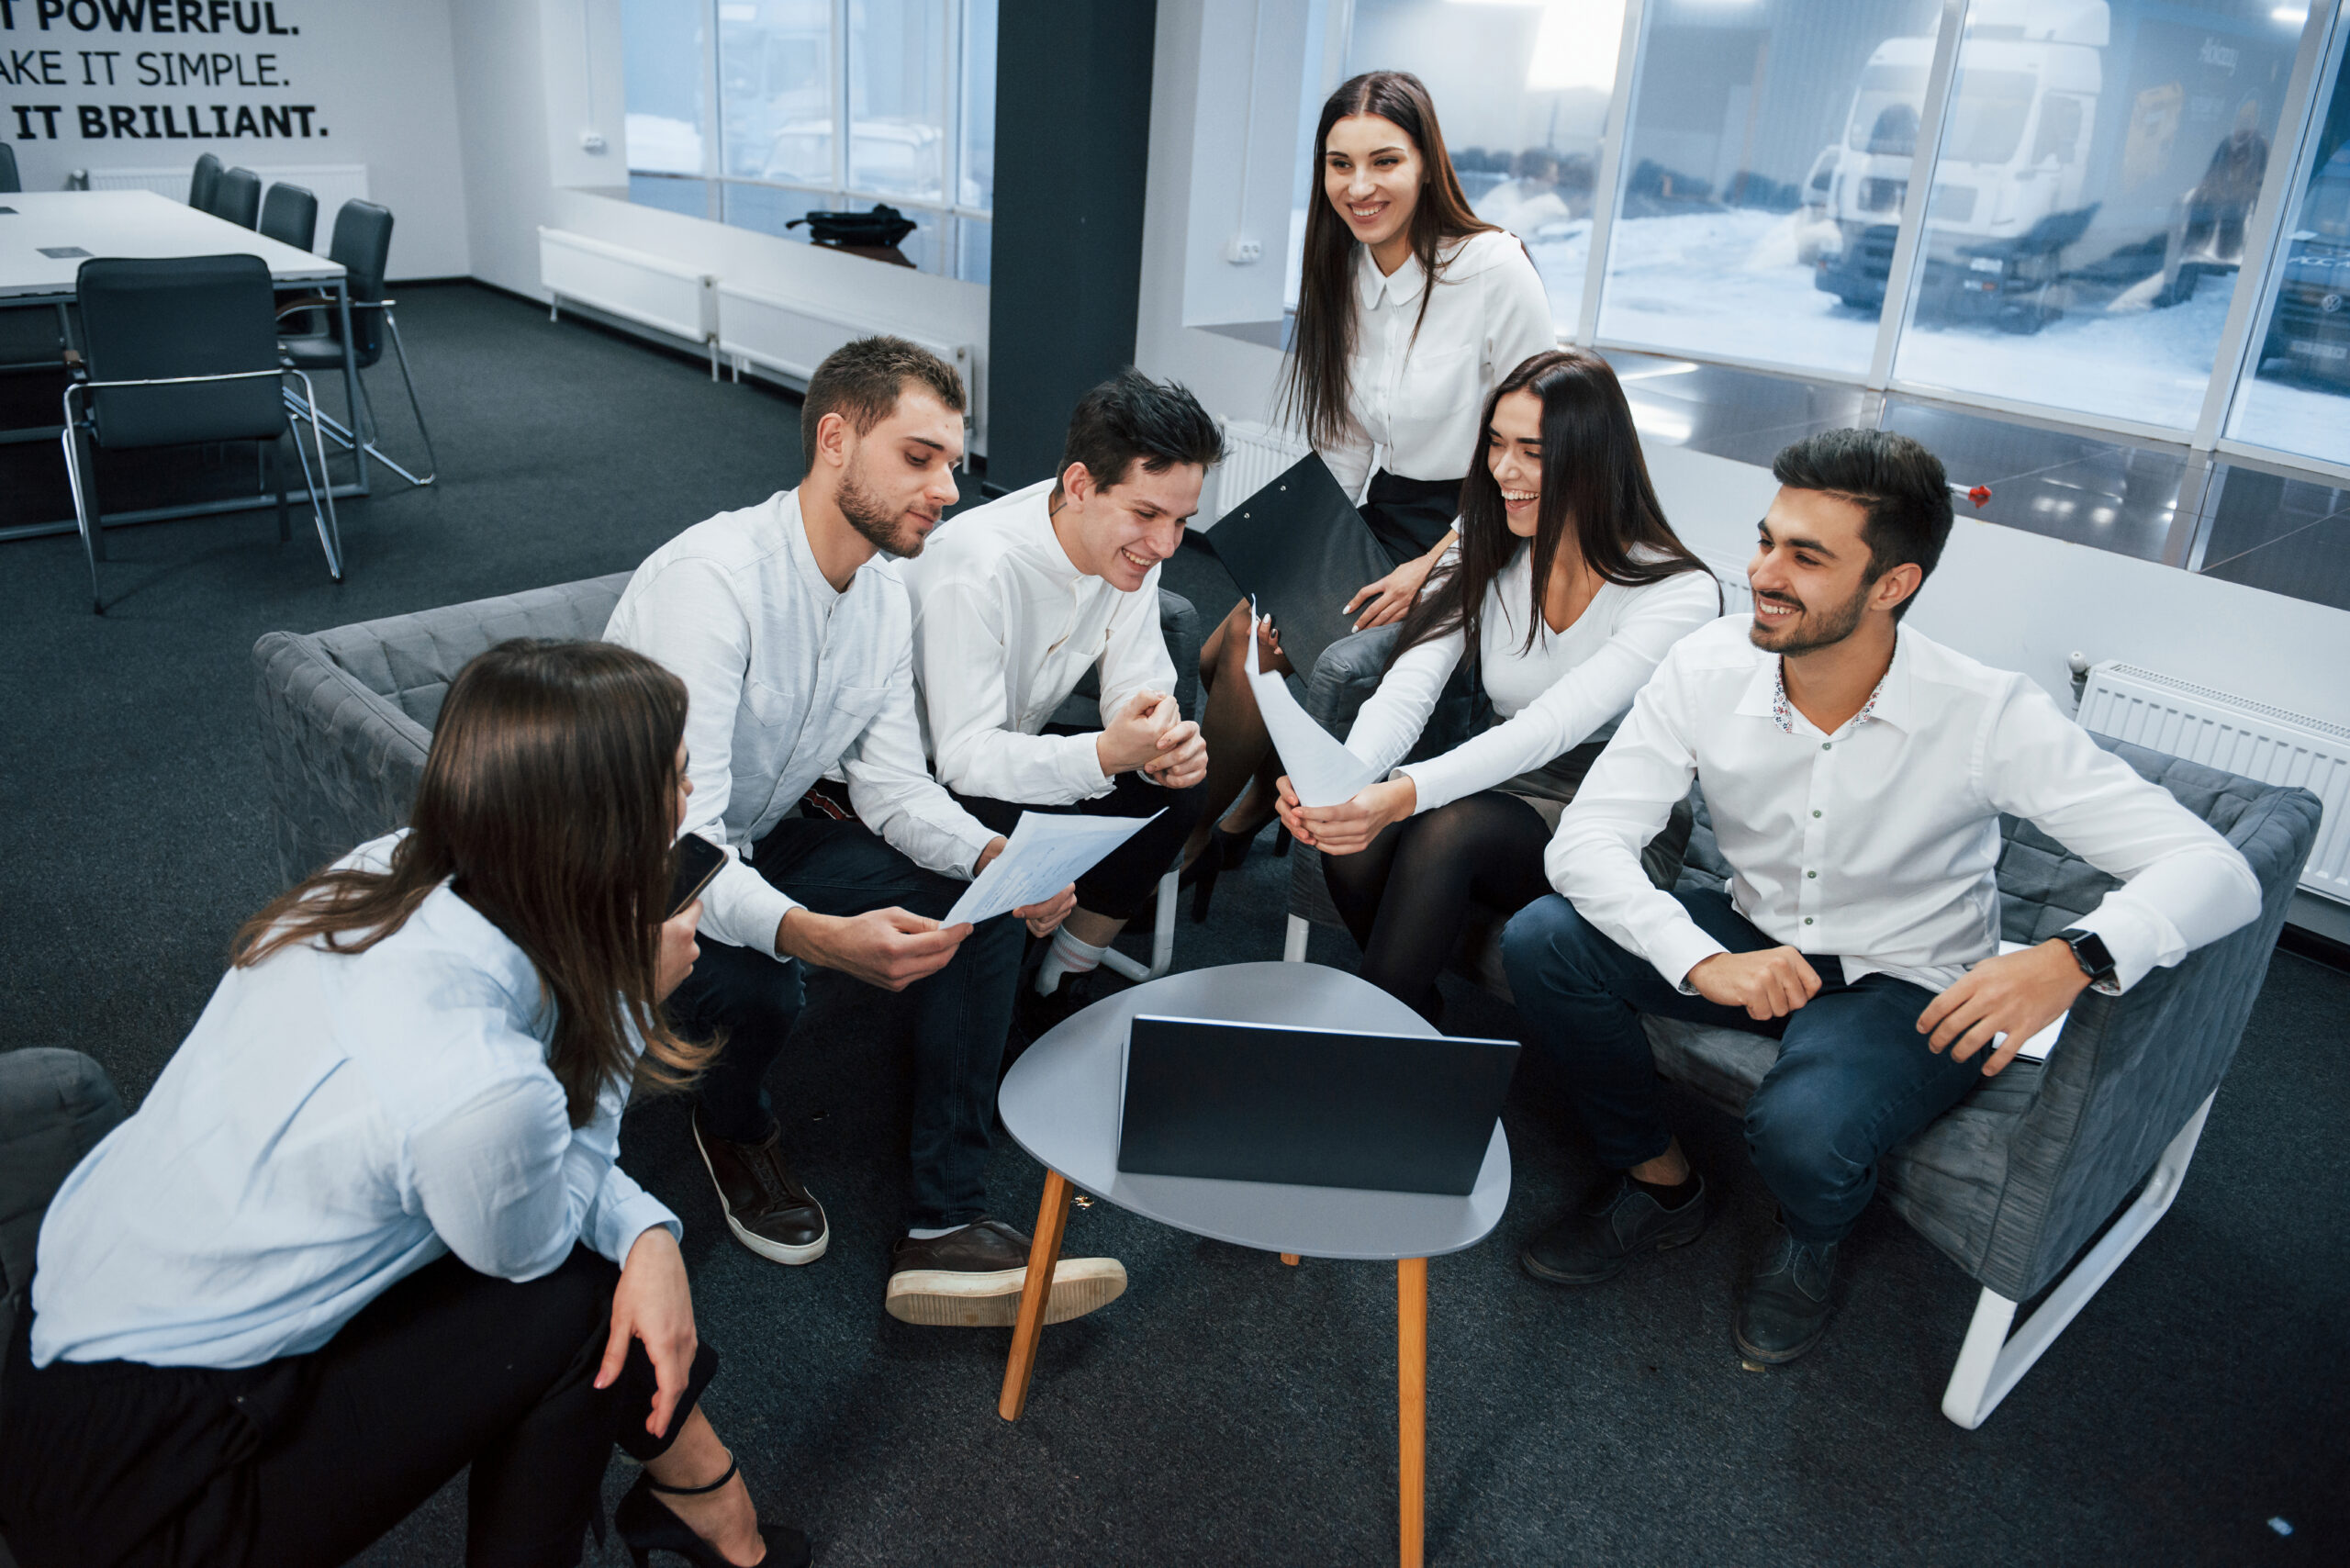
top-left (665, 816), bottom-right (1024, 1227)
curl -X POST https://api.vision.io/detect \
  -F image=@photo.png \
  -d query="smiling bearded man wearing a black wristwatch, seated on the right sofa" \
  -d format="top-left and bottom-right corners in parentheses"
top-left (1504, 431), bottom-right (2261, 1361)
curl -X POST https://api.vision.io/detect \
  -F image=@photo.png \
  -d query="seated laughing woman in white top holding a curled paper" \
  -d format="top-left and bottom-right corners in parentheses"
top-left (1279, 348), bottom-right (1720, 1018)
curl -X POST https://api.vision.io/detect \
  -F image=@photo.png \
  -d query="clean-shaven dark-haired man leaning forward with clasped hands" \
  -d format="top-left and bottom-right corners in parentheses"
top-left (900, 369), bottom-right (1225, 1032)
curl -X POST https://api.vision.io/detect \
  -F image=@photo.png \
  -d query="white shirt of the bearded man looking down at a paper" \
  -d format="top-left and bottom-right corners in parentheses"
top-left (604, 489), bottom-right (996, 952)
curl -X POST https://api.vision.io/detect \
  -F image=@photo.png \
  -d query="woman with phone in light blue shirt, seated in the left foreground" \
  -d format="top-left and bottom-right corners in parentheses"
top-left (0, 642), bottom-right (809, 1568)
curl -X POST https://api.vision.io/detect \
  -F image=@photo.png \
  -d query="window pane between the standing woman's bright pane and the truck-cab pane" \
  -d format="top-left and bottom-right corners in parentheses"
top-left (1600, 0), bottom-right (1942, 374)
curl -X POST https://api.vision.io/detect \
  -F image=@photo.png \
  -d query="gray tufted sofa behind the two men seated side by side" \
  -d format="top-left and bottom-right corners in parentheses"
top-left (253, 571), bottom-right (1201, 884)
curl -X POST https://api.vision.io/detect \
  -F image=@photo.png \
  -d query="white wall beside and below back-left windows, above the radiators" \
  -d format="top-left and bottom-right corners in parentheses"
top-left (456, 0), bottom-right (987, 452)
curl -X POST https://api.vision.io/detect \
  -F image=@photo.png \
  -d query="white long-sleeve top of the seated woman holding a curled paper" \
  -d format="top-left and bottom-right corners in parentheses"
top-left (1347, 545), bottom-right (1722, 811)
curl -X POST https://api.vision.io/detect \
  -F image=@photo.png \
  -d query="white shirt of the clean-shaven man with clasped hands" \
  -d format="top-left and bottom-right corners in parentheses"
top-left (898, 479), bottom-right (1175, 806)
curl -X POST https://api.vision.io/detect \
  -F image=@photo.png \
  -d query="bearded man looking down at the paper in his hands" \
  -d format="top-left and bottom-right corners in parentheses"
top-left (604, 339), bottom-right (1125, 1326)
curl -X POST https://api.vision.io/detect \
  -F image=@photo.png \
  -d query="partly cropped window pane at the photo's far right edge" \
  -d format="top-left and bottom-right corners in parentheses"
top-left (2228, 10), bottom-right (2350, 465)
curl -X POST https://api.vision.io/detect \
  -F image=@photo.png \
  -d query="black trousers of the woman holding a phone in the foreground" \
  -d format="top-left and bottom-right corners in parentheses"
top-left (0, 1249), bottom-right (717, 1568)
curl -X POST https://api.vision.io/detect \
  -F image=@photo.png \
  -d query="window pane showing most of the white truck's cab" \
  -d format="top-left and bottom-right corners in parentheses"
top-left (1894, 0), bottom-right (2308, 431)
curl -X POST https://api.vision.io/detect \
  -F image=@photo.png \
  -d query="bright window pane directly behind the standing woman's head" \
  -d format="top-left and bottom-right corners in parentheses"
top-left (1335, 0), bottom-right (1624, 336)
